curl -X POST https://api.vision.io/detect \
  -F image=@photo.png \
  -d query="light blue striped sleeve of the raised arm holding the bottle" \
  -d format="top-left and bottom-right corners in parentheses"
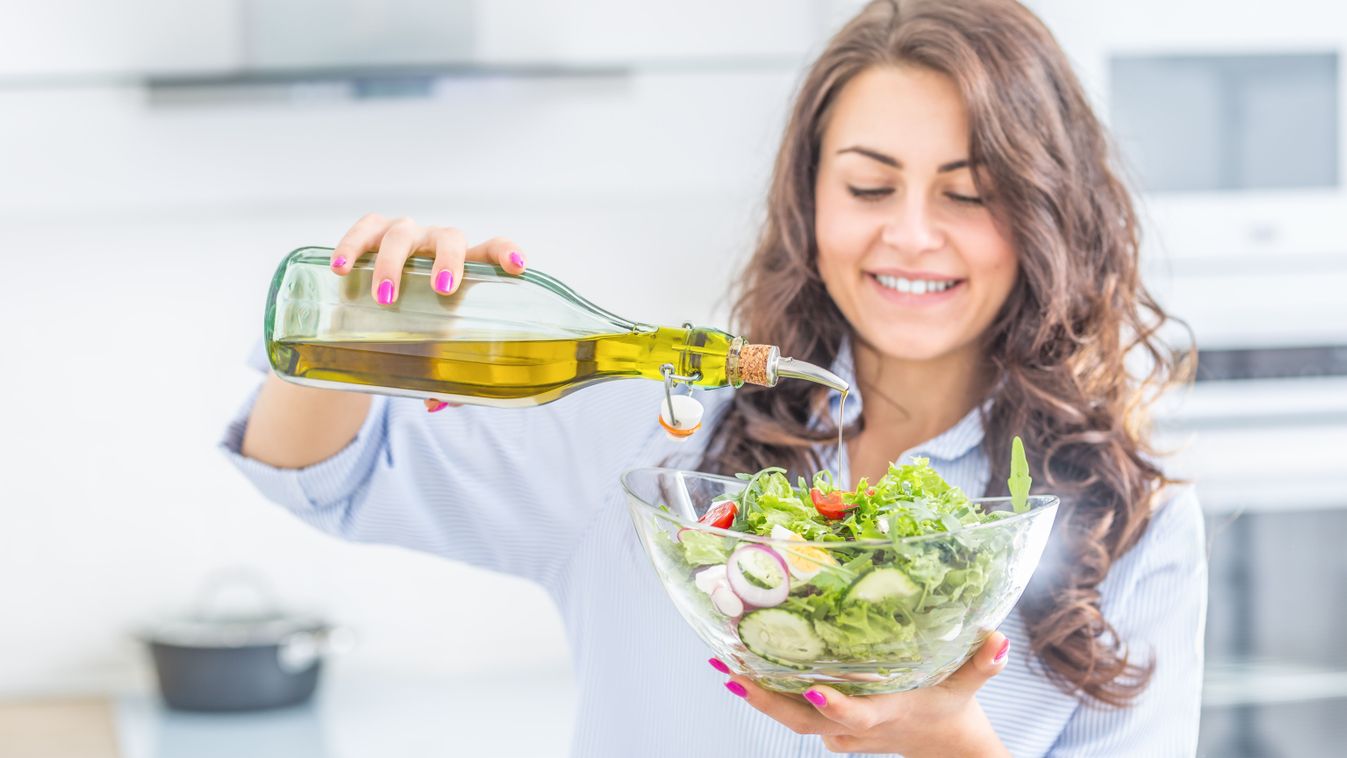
top-left (221, 371), bottom-right (673, 586)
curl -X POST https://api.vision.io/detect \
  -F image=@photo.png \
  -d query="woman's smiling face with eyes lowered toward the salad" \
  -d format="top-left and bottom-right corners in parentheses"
top-left (814, 66), bottom-right (1018, 361)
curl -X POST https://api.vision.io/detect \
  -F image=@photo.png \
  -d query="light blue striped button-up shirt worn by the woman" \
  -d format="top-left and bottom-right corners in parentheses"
top-left (222, 351), bottom-right (1207, 758)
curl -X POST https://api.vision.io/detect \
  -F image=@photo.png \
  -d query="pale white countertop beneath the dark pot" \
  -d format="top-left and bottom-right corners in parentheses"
top-left (113, 666), bottom-right (575, 758)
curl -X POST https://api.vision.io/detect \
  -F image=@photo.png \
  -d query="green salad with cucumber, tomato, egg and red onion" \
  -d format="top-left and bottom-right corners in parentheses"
top-left (664, 438), bottom-right (1029, 672)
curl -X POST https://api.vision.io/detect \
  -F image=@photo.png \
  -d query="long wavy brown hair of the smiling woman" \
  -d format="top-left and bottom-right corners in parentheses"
top-left (700, 0), bottom-right (1191, 705)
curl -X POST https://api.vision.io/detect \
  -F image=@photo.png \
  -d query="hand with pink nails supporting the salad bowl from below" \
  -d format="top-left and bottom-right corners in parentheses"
top-left (711, 631), bottom-right (1010, 758)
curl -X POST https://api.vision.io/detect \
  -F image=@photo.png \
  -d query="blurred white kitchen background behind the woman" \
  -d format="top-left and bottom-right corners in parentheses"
top-left (0, 0), bottom-right (1347, 758)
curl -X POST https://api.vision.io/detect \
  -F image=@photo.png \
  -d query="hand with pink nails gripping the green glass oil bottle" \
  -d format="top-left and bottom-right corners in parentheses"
top-left (331, 213), bottom-right (524, 413)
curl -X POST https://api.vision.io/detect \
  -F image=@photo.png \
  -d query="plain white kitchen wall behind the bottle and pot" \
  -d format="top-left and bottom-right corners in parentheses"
top-left (0, 77), bottom-right (793, 692)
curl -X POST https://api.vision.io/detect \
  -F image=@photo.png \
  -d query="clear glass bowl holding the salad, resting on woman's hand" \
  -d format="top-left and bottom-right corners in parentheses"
top-left (622, 469), bottom-right (1057, 695)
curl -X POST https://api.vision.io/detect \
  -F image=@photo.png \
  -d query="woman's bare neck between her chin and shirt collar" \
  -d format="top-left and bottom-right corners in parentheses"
top-left (853, 339), bottom-right (989, 460)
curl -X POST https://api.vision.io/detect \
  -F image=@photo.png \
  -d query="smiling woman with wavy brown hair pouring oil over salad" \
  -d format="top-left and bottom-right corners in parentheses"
top-left (225, 0), bottom-right (1206, 758)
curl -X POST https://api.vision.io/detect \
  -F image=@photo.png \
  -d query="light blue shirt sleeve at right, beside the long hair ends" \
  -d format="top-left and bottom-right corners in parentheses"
top-left (1049, 487), bottom-right (1207, 758)
